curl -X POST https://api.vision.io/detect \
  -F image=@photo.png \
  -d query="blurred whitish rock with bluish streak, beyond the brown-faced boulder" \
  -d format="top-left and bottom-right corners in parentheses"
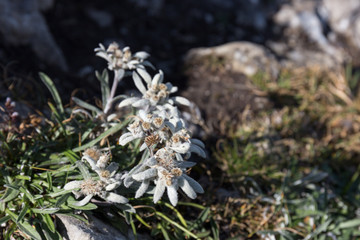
top-left (269, 0), bottom-right (347, 68)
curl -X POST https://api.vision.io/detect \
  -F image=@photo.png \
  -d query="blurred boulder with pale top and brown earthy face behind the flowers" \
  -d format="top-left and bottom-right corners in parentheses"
top-left (182, 42), bottom-right (279, 132)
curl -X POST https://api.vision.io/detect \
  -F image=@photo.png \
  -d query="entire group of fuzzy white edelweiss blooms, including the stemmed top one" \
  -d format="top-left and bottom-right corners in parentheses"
top-left (64, 43), bottom-right (206, 206)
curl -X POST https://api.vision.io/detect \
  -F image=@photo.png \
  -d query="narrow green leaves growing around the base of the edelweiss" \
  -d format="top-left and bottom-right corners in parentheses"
top-left (0, 73), bottom-right (218, 239)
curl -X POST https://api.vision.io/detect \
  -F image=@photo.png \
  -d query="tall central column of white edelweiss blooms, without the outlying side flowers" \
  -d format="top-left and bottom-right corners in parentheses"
top-left (119, 50), bottom-right (206, 206)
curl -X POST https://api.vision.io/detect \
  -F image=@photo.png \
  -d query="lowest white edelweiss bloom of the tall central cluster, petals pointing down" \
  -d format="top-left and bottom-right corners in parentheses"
top-left (124, 148), bottom-right (204, 206)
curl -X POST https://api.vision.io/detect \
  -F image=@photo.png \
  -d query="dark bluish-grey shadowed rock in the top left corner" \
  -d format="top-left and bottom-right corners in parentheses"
top-left (0, 0), bottom-right (68, 71)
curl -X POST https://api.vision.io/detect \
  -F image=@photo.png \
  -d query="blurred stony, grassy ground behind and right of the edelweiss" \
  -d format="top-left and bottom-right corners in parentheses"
top-left (0, 0), bottom-right (360, 239)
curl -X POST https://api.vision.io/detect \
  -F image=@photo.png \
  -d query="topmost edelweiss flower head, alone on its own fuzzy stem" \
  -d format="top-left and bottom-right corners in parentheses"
top-left (95, 42), bottom-right (149, 70)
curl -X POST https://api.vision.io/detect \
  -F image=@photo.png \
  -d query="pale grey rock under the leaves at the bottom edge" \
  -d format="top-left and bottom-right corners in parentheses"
top-left (56, 214), bottom-right (149, 240)
